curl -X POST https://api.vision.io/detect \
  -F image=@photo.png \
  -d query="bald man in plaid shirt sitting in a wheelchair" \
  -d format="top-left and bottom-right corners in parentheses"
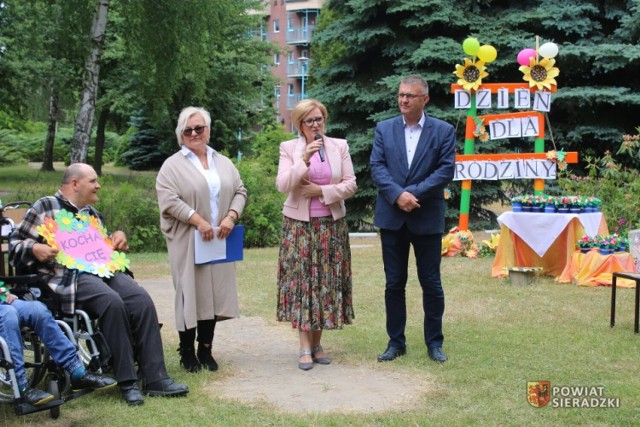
top-left (9, 163), bottom-right (189, 405)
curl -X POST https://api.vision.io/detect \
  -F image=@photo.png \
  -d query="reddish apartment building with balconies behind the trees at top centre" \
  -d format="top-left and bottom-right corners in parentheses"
top-left (254, 0), bottom-right (325, 132)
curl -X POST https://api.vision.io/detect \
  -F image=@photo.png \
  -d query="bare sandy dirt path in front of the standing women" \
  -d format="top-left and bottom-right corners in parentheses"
top-left (140, 279), bottom-right (432, 413)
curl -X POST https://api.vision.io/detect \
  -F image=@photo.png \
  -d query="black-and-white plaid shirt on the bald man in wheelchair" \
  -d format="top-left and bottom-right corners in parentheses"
top-left (9, 190), bottom-right (104, 314)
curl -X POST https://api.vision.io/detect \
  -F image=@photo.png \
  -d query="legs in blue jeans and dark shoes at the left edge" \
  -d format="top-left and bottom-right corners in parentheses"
top-left (0, 288), bottom-right (116, 406)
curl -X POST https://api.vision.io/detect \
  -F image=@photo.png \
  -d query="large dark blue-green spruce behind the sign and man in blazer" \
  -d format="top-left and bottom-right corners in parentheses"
top-left (310, 0), bottom-right (640, 231)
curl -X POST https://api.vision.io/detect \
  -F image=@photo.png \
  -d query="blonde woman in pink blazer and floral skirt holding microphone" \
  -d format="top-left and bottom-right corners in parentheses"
top-left (276, 99), bottom-right (357, 370)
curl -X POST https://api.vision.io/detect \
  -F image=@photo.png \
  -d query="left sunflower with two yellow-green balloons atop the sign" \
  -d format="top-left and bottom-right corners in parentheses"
top-left (453, 37), bottom-right (498, 92)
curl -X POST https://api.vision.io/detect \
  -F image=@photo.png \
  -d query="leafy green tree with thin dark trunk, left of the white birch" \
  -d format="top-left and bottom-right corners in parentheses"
top-left (0, 0), bottom-right (90, 171)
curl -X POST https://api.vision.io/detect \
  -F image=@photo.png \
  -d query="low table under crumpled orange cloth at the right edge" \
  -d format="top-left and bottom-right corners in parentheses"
top-left (556, 249), bottom-right (636, 288)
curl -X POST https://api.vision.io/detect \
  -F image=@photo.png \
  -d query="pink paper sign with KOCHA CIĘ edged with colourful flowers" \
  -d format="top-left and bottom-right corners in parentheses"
top-left (38, 209), bottom-right (131, 277)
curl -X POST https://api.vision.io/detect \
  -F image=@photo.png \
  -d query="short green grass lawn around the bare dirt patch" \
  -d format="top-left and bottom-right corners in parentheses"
top-left (0, 239), bottom-right (640, 426)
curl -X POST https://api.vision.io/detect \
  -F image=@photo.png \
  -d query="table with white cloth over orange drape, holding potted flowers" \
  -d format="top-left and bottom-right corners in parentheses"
top-left (491, 212), bottom-right (609, 277)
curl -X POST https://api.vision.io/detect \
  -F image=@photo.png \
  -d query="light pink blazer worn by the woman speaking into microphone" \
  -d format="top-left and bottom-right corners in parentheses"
top-left (276, 136), bottom-right (358, 221)
